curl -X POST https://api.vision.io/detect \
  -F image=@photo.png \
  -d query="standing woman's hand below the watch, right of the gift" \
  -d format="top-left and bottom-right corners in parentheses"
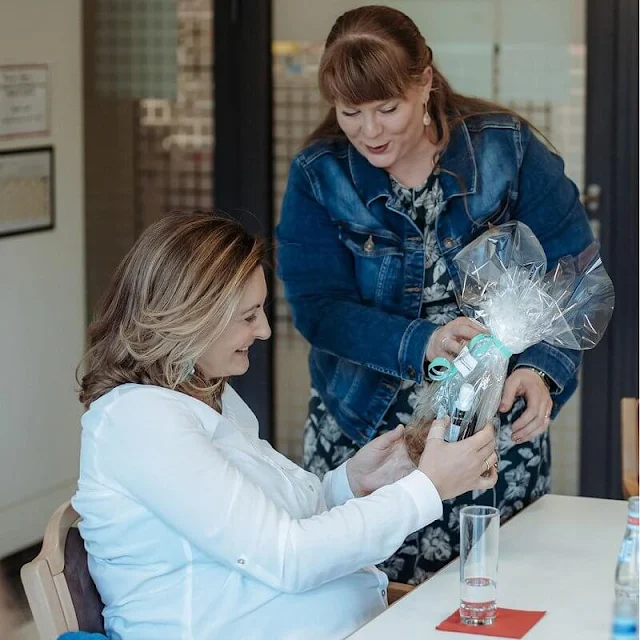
top-left (499, 367), bottom-right (553, 444)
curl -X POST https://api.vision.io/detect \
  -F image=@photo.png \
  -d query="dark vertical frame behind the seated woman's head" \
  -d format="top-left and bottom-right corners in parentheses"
top-left (213, 0), bottom-right (274, 440)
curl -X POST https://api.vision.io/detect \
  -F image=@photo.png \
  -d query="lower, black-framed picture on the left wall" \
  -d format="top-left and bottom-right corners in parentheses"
top-left (0, 147), bottom-right (55, 236)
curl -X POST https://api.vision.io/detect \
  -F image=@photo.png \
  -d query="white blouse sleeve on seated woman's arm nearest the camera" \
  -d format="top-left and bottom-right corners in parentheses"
top-left (106, 391), bottom-right (442, 593)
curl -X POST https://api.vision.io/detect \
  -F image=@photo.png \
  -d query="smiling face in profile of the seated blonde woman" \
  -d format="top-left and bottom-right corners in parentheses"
top-left (197, 267), bottom-right (271, 378)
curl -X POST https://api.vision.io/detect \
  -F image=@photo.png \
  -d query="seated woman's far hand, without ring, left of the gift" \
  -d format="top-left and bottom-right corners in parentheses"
top-left (347, 424), bottom-right (416, 498)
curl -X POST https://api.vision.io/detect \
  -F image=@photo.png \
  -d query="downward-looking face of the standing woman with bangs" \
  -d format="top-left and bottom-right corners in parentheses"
top-left (335, 74), bottom-right (431, 175)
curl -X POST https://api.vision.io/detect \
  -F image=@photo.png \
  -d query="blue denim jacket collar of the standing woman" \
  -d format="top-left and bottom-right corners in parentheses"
top-left (348, 122), bottom-right (478, 207)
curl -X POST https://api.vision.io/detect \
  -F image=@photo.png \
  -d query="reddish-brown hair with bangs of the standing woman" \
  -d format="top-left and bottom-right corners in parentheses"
top-left (306, 5), bottom-right (526, 151)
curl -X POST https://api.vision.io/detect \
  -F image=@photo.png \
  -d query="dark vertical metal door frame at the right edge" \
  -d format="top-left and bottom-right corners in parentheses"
top-left (580, 0), bottom-right (639, 498)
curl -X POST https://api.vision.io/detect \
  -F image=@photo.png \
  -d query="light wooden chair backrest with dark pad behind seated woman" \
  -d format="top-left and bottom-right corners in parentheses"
top-left (20, 502), bottom-right (104, 640)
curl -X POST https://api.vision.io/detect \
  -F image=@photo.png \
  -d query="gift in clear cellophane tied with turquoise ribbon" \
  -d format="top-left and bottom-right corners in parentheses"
top-left (407, 221), bottom-right (615, 460)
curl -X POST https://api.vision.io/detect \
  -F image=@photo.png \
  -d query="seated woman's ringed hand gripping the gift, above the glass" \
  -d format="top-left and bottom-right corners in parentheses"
top-left (418, 419), bottom-right (498, 500)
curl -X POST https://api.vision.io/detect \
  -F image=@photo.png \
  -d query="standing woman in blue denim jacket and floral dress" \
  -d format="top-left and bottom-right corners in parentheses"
top-left (277, 6), bottom-right (593, 583)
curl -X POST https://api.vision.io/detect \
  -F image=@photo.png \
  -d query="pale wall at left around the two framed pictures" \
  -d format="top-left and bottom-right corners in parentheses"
top-left (0, 0), bottom-right (84, 556)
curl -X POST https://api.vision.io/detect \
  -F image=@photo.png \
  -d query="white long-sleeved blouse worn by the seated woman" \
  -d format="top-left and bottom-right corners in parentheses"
top-left (72, 384), bottom-right (442, 640)
